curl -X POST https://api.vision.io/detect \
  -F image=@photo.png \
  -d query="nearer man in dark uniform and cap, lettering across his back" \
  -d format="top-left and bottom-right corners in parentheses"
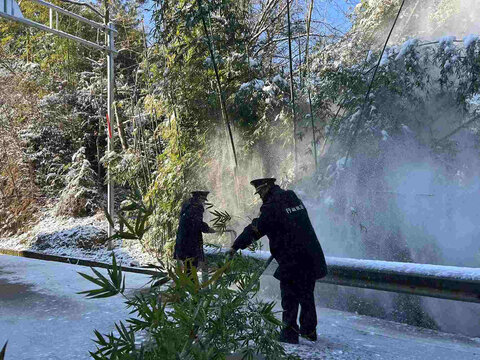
top-left (229, 178), bottom-right (327, 344)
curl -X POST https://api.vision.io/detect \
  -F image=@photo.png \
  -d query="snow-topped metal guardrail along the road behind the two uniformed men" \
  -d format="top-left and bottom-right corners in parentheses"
top-left (207, 250), bottom-right (480, 303)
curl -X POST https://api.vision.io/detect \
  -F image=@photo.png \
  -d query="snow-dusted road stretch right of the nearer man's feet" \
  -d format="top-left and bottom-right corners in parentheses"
top-left (280, 308), bottom-right (480, 360)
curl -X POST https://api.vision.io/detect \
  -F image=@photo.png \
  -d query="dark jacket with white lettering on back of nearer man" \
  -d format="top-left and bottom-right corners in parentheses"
top-left (232, 185), bottom-right (327, 280)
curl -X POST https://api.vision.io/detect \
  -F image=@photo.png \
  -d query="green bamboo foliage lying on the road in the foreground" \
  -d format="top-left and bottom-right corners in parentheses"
top-left (82, 256), bottom-right (293, 360)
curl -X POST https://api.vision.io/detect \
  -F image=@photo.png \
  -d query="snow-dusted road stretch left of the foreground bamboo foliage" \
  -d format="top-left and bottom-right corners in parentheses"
top-left (0, 255), bottom-right (149, 360)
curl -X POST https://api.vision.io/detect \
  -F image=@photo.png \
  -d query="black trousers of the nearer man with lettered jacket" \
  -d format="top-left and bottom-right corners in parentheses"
top-left (280, 278), bottom-right (317, 336)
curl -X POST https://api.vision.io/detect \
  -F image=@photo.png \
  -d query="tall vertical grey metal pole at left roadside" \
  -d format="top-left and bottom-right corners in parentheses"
top-left (107, 22), bottom-right (114, 245)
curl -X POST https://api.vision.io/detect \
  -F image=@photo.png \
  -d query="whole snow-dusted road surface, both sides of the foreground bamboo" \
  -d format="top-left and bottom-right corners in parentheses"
top-left (0, 255), bottom-right (480, 360)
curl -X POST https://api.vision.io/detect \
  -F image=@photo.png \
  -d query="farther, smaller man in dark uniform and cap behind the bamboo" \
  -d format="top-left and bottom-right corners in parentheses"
top-left (173, 191), bottom-right (215, 274)
